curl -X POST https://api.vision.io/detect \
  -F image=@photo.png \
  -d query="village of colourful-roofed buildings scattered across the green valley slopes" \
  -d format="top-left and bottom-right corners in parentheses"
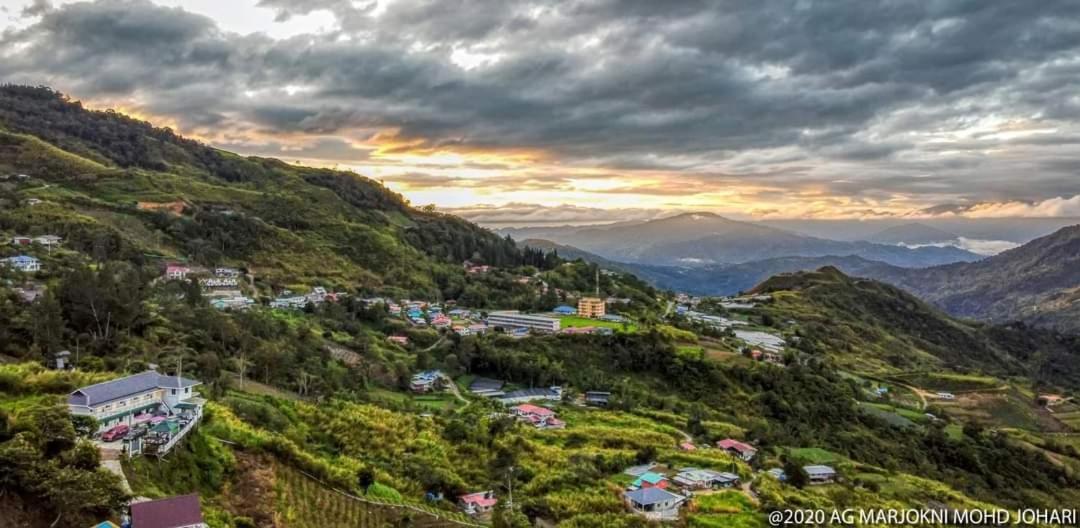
top-left (3, 235), bottom-right (881, 528)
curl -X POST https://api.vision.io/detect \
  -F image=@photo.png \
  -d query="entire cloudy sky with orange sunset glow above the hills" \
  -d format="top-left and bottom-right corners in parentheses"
top-left (0, 0), bottom-right (1080, 221)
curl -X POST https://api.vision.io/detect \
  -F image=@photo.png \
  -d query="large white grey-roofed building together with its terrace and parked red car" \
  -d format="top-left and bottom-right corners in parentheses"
top-left (67, 368), bottom-right (206, 457)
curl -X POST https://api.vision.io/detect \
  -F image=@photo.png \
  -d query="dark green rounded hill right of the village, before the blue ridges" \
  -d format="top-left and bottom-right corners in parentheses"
top-left (754, 267), bottom-right (1080, 388)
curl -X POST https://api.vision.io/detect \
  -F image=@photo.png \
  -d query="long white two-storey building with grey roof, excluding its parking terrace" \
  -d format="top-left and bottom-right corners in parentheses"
top-left (68, 370), bottom-right (206, 432)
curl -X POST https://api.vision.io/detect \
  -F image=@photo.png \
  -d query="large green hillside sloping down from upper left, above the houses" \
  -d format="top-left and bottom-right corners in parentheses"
top-left (0, 85), bottom-right (531, 296)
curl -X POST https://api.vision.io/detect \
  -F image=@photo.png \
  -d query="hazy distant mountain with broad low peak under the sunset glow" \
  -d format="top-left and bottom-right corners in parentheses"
top-left (501, 213), bottom-right (981, 268)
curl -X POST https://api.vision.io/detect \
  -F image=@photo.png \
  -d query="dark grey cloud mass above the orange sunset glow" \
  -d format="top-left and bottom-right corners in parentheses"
top-left (6, 0), bottom-right (1080, 205)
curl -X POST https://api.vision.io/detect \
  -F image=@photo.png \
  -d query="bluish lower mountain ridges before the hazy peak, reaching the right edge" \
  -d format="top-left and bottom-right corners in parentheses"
top-left (528, 225), bottom-right (1080, 333)
